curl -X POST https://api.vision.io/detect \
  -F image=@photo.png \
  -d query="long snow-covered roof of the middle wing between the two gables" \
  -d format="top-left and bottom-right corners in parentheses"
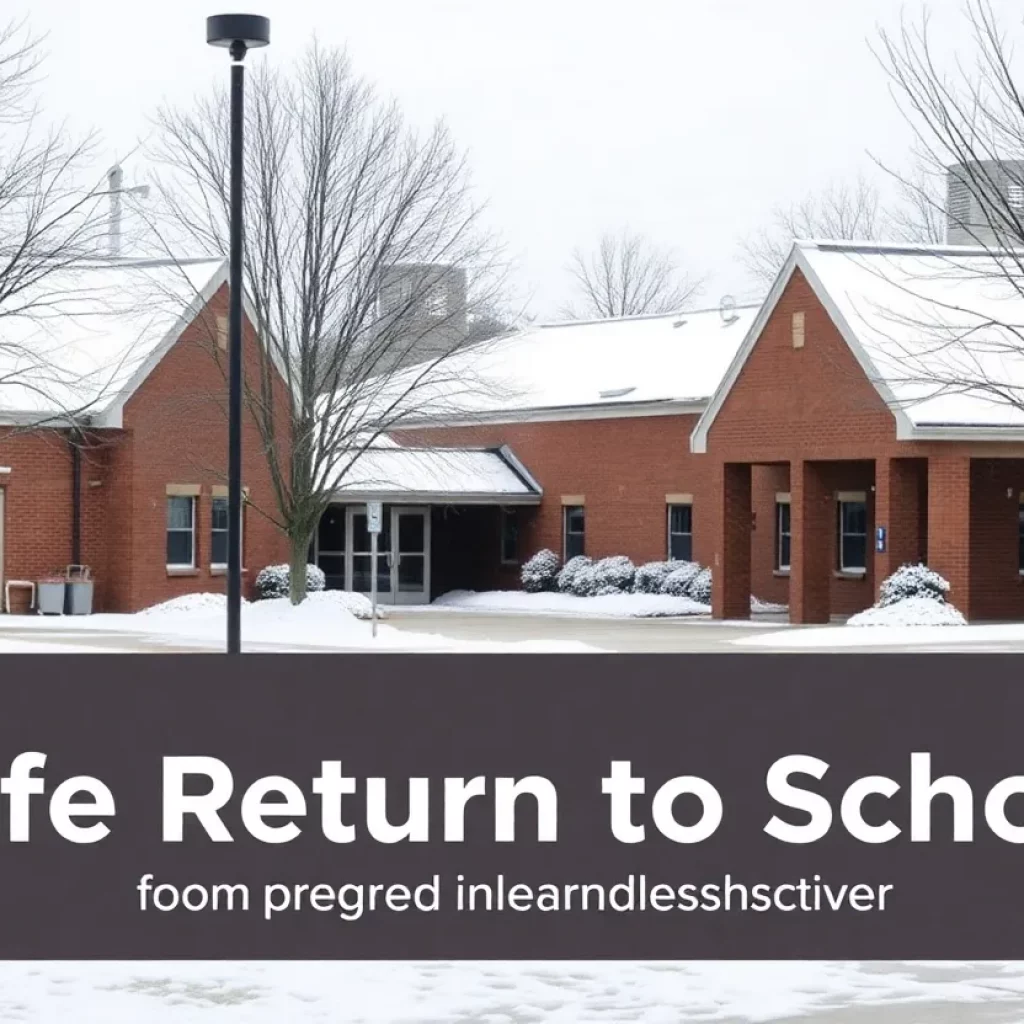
top-left (395, 306), bottom-right (758, 422)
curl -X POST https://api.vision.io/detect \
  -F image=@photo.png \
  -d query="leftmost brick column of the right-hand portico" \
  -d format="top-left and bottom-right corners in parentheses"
top-left (712, 462), bottom-right (752, 618)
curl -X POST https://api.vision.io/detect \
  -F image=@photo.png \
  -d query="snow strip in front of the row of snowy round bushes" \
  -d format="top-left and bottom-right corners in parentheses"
top-left (421, 590), bottom-right (786, 618)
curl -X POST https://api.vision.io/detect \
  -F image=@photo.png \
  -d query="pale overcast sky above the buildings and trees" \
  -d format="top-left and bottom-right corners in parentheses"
top-left (4, 0), bottom-right (1024, 318)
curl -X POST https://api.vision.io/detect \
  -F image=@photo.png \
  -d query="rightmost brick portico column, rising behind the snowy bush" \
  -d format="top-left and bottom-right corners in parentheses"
top-left (928, 456), bottom-right (971, 618)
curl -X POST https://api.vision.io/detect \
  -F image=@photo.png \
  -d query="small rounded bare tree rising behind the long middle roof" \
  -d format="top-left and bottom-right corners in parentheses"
top-left (563, 230), bottom-right (701, 319)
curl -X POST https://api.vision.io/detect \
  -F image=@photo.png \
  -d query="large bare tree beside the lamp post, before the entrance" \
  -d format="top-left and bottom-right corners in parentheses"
top-left (156, 45), bottom-right (502, 603)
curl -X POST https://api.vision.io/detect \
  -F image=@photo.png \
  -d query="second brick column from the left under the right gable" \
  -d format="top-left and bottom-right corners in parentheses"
top-left (790, 461), bottom-right (837, 624)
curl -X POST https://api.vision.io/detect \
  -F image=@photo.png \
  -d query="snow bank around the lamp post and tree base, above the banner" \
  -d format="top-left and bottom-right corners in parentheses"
top-left (0, 591), bottom-right (596, 653)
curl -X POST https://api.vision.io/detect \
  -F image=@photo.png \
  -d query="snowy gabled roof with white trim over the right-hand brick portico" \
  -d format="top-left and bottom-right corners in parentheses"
top-left (691, 242), bottom-right (1024, 452)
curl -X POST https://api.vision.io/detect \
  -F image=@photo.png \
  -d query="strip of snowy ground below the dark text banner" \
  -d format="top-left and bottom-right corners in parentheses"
top-left (0, 962), bottom-right (1024, 1024)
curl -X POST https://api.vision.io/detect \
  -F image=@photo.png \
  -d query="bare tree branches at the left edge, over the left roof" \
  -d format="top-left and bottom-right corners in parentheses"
top-left (0, 23), bottom-right (132, 428)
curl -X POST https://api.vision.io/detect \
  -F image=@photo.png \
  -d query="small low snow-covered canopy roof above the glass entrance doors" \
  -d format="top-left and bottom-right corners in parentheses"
top-left (335, 442), bottom-right (542, 505)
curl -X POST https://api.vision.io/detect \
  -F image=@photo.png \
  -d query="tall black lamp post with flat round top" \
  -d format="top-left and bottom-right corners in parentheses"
top-left (206, 14), bottom-right (270, 654)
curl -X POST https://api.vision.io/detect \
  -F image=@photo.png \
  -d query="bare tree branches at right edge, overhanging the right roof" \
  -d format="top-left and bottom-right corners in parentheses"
top-left (860, 0), bottom-right (1024, 409)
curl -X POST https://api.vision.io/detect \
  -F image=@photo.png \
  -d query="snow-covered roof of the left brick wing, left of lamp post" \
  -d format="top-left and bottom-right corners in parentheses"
top-left (0, 258), bottom-right (226, 426)
